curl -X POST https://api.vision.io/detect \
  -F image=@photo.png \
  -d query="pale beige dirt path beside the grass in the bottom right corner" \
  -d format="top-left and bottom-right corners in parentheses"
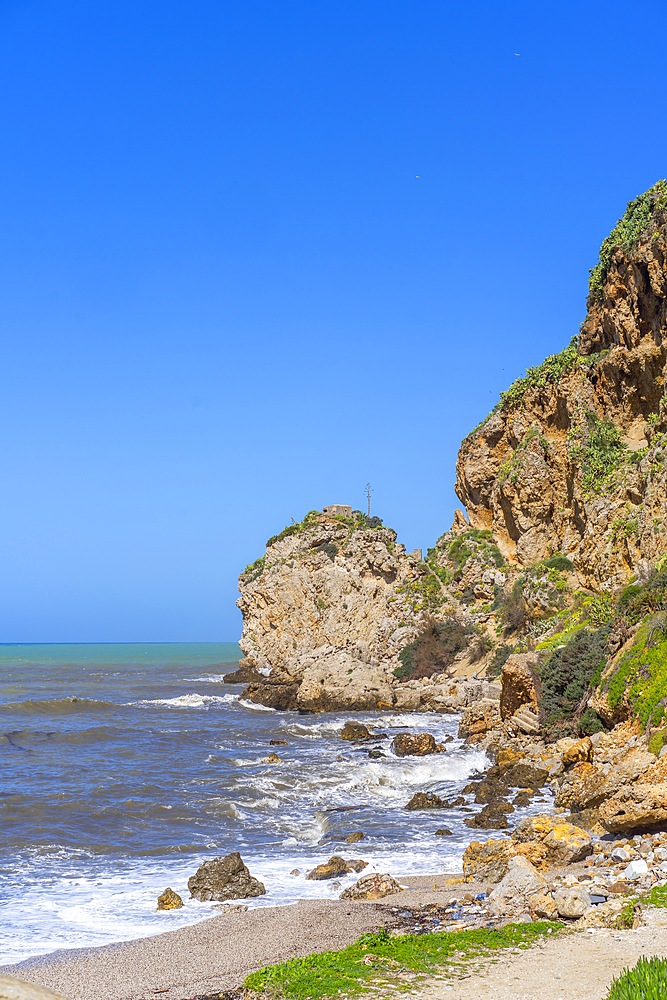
top-left (418, 927), bottom-right (667, 1000)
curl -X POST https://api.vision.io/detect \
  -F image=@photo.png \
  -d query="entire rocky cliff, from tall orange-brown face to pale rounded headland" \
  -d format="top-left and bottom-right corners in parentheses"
top-left (238, 181), bottom-right (667, 732)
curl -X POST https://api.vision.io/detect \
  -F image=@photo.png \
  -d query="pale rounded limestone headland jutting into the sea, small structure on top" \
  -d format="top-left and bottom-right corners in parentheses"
top-left (238, 512), bottom-right (423, 711)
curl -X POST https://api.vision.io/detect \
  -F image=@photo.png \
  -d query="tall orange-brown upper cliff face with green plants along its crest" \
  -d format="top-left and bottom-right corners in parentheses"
top-left (456, 182), bottom-right (667, 590)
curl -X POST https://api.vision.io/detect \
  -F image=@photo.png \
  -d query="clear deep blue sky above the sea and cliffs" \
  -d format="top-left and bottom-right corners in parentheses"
top-left (0, 0), bottom-right (667, 642)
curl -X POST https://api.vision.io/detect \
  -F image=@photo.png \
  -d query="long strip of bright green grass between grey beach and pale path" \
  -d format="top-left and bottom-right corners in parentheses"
top-left (243, 921), bottom-right (563, 1000)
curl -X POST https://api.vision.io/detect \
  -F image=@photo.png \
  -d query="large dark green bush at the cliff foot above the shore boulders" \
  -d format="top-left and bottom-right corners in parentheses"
top-left (539, 625), bottom-right (609, 724)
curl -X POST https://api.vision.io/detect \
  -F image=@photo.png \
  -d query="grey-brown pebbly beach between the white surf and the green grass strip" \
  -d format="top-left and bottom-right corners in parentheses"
top-left (0, 875), bottom-right (471, 1000)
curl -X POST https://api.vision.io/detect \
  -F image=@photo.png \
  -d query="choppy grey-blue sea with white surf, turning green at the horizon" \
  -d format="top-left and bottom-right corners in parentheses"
top-left (0, 643), bottom-right (544, 964)
